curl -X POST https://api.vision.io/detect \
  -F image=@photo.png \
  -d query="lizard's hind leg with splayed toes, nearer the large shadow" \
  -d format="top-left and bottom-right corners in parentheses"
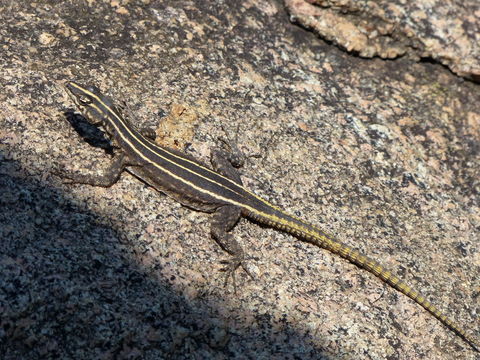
top-left (211, 205), bottom-right (253, 292)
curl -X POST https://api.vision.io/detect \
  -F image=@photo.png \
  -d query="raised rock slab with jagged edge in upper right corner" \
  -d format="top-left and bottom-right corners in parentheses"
top-left (285, 0), bottom-right (480, 82)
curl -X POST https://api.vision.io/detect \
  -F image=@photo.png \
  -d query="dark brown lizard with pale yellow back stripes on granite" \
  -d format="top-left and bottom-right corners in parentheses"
top-left (58, 81), bottom-right (480, 352)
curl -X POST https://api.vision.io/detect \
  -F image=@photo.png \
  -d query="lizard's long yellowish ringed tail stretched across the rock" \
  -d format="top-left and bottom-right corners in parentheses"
top-left (246, 204), bottom-right (480, 352)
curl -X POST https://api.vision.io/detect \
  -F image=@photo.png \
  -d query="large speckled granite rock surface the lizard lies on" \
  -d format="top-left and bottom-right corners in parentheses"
top-left (0, 0), bottom-right (480, 360)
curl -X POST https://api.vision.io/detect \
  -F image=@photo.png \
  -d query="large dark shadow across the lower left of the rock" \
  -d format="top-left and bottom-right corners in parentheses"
top-left (0, 154), bottom-right (334, 359)
